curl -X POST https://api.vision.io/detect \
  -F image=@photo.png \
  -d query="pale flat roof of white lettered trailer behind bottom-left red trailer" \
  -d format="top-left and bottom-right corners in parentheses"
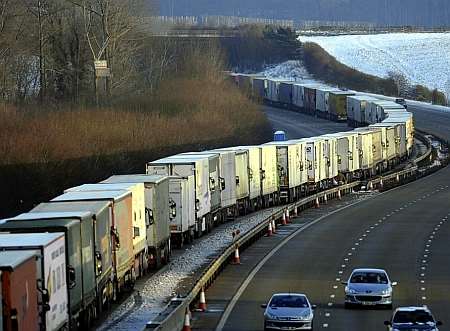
top-left (0, 232), bottom-right (64, 251)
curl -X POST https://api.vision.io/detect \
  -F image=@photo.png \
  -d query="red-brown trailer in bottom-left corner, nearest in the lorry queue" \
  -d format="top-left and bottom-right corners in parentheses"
top-left (0, 251), bottom-right (40, 331)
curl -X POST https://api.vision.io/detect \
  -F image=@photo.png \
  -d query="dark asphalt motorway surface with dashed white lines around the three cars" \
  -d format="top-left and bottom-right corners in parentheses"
top-left (194, 106), bottom-right (450, 331)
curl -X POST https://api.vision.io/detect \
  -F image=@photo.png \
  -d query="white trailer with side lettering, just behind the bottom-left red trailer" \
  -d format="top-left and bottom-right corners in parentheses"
top-left (0, 232), bottom-right (69, 331)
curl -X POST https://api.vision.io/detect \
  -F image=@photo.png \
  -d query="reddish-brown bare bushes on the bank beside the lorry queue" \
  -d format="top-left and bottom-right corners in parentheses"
top-left (0, 44), bottom-right (271, 217)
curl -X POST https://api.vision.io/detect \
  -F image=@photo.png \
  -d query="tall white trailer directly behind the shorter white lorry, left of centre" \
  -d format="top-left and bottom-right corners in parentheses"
top-left (147, 156), bottom-right (211, 233)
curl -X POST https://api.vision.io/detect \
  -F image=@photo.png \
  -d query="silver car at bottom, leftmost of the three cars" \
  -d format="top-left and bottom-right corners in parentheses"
top-left (261, 293), bottom-right (315, 330)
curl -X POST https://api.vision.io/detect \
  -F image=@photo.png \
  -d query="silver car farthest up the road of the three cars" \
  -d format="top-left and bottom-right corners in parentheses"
top-left (343, 269), bottom-right (397, 309)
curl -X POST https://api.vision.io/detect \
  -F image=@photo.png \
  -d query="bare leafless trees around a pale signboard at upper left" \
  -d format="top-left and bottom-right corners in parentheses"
top-left (0, 0), bottom-right (180, 103)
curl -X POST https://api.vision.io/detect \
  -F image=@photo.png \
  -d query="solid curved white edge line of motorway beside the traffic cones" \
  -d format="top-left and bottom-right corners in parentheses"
top-left (216, 200), bottom-right (366, 331)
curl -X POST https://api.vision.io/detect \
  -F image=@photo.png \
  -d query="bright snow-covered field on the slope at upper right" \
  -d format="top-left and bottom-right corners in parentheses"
top-left (299, 33), bottom-right (450, 95)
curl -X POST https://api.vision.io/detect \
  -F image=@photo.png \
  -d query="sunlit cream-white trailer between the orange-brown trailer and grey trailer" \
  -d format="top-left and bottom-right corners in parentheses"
top-left (64, 183), bottom-right (147, 257)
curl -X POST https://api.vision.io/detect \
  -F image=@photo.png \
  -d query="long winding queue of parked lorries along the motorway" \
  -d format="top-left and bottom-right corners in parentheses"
top-left (0, 76), bottom-right (414, 330)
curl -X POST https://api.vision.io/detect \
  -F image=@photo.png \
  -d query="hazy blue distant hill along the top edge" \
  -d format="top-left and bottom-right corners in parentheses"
top-left (156, 0), bottom-right (450, 27)
